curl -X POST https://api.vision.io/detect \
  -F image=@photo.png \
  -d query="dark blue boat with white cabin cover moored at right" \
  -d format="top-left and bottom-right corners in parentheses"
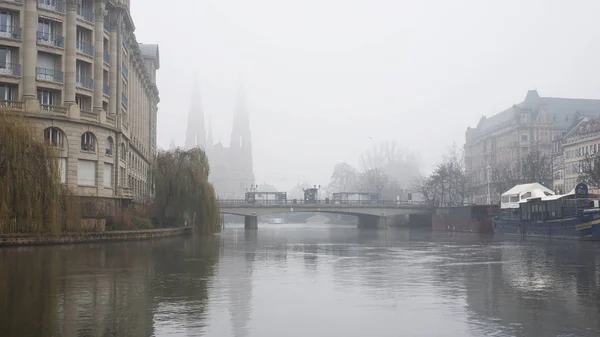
top-left (493, 183), bottom-right (600, 240)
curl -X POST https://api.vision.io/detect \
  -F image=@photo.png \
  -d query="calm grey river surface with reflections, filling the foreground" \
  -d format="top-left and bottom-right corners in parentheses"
top-left (0, 224), bottom-right (600, 337)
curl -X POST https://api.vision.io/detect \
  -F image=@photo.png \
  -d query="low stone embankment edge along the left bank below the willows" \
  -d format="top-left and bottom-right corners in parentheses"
top-left (0, 227), bottom-right (192, 247)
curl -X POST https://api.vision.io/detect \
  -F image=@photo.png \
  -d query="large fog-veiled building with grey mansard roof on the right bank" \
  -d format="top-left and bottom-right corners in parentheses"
top-left (465, 90), bottom-right (600, 204)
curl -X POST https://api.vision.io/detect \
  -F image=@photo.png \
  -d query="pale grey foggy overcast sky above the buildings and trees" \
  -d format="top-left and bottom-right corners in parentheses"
top-left (131, 0), bottom-right (600, 189)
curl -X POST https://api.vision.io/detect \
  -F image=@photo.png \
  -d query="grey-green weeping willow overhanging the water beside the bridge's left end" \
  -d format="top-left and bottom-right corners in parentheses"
top-left (152, 147), bottom-right (221, 233)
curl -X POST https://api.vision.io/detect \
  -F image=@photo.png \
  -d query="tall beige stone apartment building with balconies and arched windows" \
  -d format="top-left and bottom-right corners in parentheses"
top-left (0, 0), bottom-right (160, 199)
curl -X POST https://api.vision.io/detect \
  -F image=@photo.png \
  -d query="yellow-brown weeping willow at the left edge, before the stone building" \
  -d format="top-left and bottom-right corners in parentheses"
top-left (0, 111), bottom-right (78, 234)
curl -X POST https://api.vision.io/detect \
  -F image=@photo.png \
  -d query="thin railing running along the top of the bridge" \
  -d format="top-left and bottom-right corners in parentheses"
top-left (219, 199), bottom-right (428, 207)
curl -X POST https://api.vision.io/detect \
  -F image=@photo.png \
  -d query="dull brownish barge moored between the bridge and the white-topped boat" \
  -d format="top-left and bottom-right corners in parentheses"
top-left (431, 205), bottom-right (500, 234)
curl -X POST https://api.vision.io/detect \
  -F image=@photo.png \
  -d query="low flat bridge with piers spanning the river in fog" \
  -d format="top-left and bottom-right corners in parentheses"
top-left (219, 200), bottom-right (434, 229)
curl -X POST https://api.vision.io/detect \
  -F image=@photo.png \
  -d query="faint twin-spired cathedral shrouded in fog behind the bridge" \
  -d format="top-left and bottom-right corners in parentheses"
top-left (185, 86), bottom-right (254, 199)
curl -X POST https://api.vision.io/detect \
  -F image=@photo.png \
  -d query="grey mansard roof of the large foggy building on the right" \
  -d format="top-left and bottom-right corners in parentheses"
top-left (468, 90), bottom-right (600, 133)
